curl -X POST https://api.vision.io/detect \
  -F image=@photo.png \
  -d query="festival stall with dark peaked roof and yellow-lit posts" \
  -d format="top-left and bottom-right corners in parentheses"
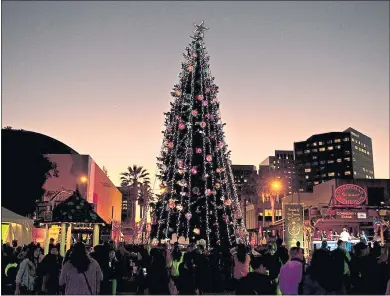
top-left (34, 190), bottom-right (105, 256)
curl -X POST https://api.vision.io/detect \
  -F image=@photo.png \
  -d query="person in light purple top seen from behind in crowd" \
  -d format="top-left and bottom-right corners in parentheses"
top-left (279, 247), bottom-right (304, 295)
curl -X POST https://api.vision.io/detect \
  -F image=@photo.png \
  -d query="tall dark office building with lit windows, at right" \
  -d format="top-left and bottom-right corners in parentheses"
top-left (294, 128), bottom-right (374, 191)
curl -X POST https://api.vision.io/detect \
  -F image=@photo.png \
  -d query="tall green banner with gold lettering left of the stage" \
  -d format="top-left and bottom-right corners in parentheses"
top-left (284, 204), bottom-right (304, 249)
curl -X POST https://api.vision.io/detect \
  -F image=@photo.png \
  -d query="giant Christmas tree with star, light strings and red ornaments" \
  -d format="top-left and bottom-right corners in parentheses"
top-left (151, 22), bottom-right (248, 249)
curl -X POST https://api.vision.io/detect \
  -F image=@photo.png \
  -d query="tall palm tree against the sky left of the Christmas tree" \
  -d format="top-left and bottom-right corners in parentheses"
top-left (121, 165), bottom-right (150, 228)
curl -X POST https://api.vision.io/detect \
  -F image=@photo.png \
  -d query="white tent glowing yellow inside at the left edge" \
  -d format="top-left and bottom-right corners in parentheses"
top-left (1, 207), bottom-right (34, 245)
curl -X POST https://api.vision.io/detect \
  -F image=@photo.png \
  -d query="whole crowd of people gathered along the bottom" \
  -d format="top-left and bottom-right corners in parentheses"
top-left (2, 239), bottom-right (390, 295)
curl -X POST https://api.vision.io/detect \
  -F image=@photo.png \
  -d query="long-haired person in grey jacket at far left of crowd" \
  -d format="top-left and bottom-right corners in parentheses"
top-left (15, 244), bottom-right (40, 295)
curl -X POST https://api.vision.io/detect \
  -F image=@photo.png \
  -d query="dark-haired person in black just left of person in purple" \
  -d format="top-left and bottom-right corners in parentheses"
top-left (236, 256), bottom-right (275, 295)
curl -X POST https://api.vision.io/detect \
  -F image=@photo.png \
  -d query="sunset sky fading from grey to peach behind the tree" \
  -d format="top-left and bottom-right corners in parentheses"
top-left (1, 1), bottom-right (390, 184)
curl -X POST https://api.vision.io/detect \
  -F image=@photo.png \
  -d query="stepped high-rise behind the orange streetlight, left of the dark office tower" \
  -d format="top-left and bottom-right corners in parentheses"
top-left (259, 150), bottom-right (295, 194)
